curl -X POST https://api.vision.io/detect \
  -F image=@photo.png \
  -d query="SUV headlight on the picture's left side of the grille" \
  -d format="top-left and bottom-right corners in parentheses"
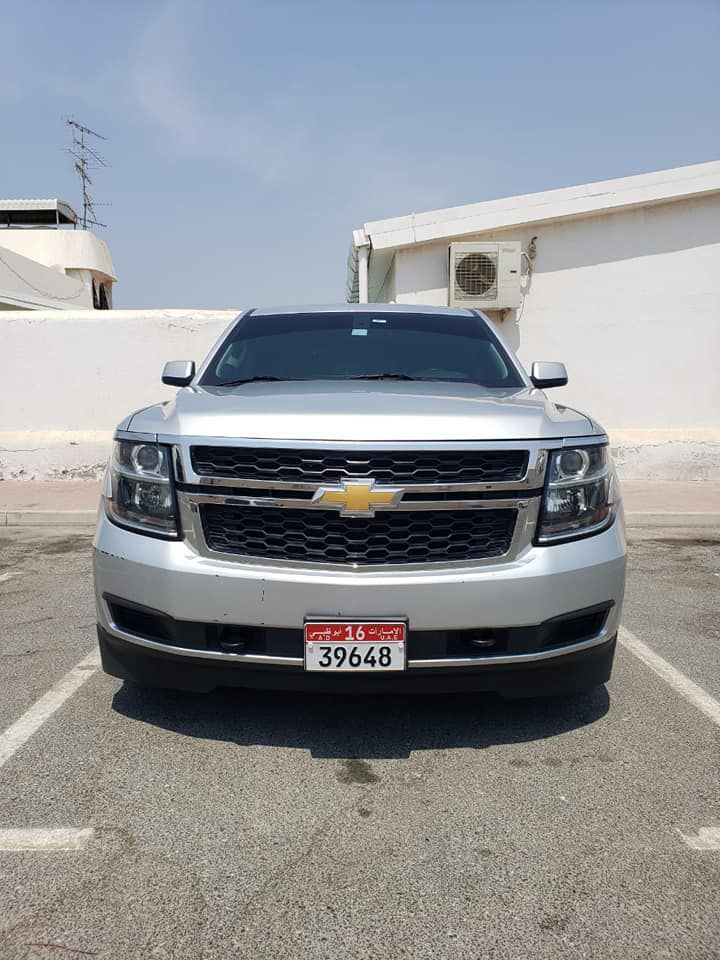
top-left (106, 440), bottom-right (178, 537)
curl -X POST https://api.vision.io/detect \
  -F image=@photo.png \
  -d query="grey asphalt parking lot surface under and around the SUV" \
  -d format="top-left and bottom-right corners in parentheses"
top-left (0, 522), bottom-right (720, 960)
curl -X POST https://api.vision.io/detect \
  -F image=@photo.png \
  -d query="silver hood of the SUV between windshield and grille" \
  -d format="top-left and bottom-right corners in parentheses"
top-left (125, 381), bottom-right (601, 442)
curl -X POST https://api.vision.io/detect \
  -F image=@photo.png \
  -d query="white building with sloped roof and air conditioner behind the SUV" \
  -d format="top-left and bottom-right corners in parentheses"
top-left (347, 161), bottom-right (720, 479)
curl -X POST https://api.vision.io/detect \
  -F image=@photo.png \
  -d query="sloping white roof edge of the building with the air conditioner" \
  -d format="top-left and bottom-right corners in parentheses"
top-left (347, 160), bottom-right (720, 300)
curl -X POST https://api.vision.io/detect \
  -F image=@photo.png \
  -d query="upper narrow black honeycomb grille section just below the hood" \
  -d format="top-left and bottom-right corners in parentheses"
top-left (191, 447), bottom-right (528, 484)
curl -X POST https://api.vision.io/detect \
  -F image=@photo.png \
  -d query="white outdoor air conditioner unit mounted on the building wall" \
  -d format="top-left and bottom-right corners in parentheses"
top-left (448, 240), bottom-right (521, 310)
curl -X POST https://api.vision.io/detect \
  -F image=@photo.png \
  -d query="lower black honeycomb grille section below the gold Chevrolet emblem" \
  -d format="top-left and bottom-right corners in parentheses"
top-left (200, 504), bottom-right (517, 565)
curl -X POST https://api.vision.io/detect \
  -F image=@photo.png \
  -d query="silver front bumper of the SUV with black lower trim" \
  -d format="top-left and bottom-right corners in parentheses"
top-left (94, 512), bottom-right (625, 695)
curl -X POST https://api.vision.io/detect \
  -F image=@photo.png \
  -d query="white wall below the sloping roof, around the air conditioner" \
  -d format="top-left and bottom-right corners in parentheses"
top-left (372, 197), bottom-right (720, 479)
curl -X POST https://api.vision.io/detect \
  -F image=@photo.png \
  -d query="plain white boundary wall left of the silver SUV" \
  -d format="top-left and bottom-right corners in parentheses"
top-left (0, 310), bottom-right (239, 479)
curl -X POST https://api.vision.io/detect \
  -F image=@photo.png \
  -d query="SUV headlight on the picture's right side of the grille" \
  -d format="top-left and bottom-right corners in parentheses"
top-left (537, 446), bottom-right (618, 543)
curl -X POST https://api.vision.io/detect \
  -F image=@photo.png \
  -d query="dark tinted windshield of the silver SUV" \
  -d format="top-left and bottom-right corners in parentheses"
top-left (201, 311), bottom-right (524, 388)
